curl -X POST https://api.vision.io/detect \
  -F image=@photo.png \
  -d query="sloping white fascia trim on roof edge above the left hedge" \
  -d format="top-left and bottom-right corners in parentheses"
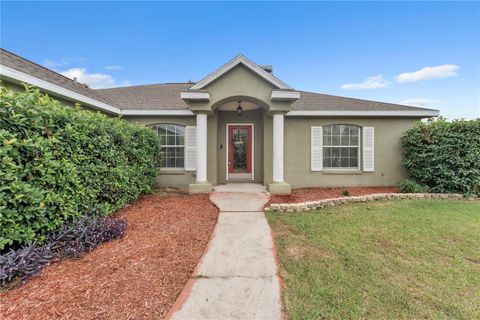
top-left (0, 64), bottom-right (122, 114)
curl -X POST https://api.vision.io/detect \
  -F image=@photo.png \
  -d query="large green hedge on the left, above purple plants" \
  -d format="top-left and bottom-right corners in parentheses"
top-left (0, 87), bottom-right (160, 250)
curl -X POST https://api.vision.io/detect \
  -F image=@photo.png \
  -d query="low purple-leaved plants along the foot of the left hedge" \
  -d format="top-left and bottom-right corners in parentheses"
top-left (0, 217), bottom-right (127, 288)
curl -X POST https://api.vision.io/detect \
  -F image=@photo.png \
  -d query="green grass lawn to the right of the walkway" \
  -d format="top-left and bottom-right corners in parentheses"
top-left (267, 200), bottom-right (480, 319)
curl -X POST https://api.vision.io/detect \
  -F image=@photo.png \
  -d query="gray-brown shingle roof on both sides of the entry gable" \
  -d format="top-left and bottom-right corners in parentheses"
top-left (0, 48), bottom-right (433, 111)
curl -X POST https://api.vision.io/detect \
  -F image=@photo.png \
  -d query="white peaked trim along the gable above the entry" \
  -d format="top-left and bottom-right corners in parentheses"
top-left (190, 54), bottom-right (292, 90)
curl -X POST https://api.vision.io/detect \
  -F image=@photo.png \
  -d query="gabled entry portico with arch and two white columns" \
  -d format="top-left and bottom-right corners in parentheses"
top-left (181, 55), bottom-right (300, 193)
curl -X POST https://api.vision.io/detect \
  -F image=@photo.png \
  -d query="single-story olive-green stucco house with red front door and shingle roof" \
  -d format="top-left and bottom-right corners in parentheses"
top-left (0, 49), bottom-right (439, 193)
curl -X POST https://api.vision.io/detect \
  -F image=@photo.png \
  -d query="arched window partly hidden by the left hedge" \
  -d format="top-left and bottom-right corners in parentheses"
top-left (149, 123), bottom-right (185, 168)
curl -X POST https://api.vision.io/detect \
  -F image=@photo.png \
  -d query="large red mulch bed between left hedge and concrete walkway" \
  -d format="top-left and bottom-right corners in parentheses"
top-left (0, 195), bottom-right (218, 320)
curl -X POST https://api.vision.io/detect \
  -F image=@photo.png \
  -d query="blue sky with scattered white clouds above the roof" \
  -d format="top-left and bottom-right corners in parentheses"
top-left (1, 1), bottom-right (480, 118)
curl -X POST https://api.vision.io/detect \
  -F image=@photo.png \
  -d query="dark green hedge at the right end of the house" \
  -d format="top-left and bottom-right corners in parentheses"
top-left (401, 118), bottom-right (480, 194)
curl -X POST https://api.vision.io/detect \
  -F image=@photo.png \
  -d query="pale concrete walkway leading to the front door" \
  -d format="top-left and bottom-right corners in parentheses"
top-left (171, 184), bottom-right (282, 320)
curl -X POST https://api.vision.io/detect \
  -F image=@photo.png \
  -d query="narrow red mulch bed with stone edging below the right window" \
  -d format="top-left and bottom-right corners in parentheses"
top-left (270, 187), bottom-right (399, 203)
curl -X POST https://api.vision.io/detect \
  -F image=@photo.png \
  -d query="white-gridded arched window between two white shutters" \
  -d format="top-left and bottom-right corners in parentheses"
top-left (323, 124), bottom-right (360, 169)
